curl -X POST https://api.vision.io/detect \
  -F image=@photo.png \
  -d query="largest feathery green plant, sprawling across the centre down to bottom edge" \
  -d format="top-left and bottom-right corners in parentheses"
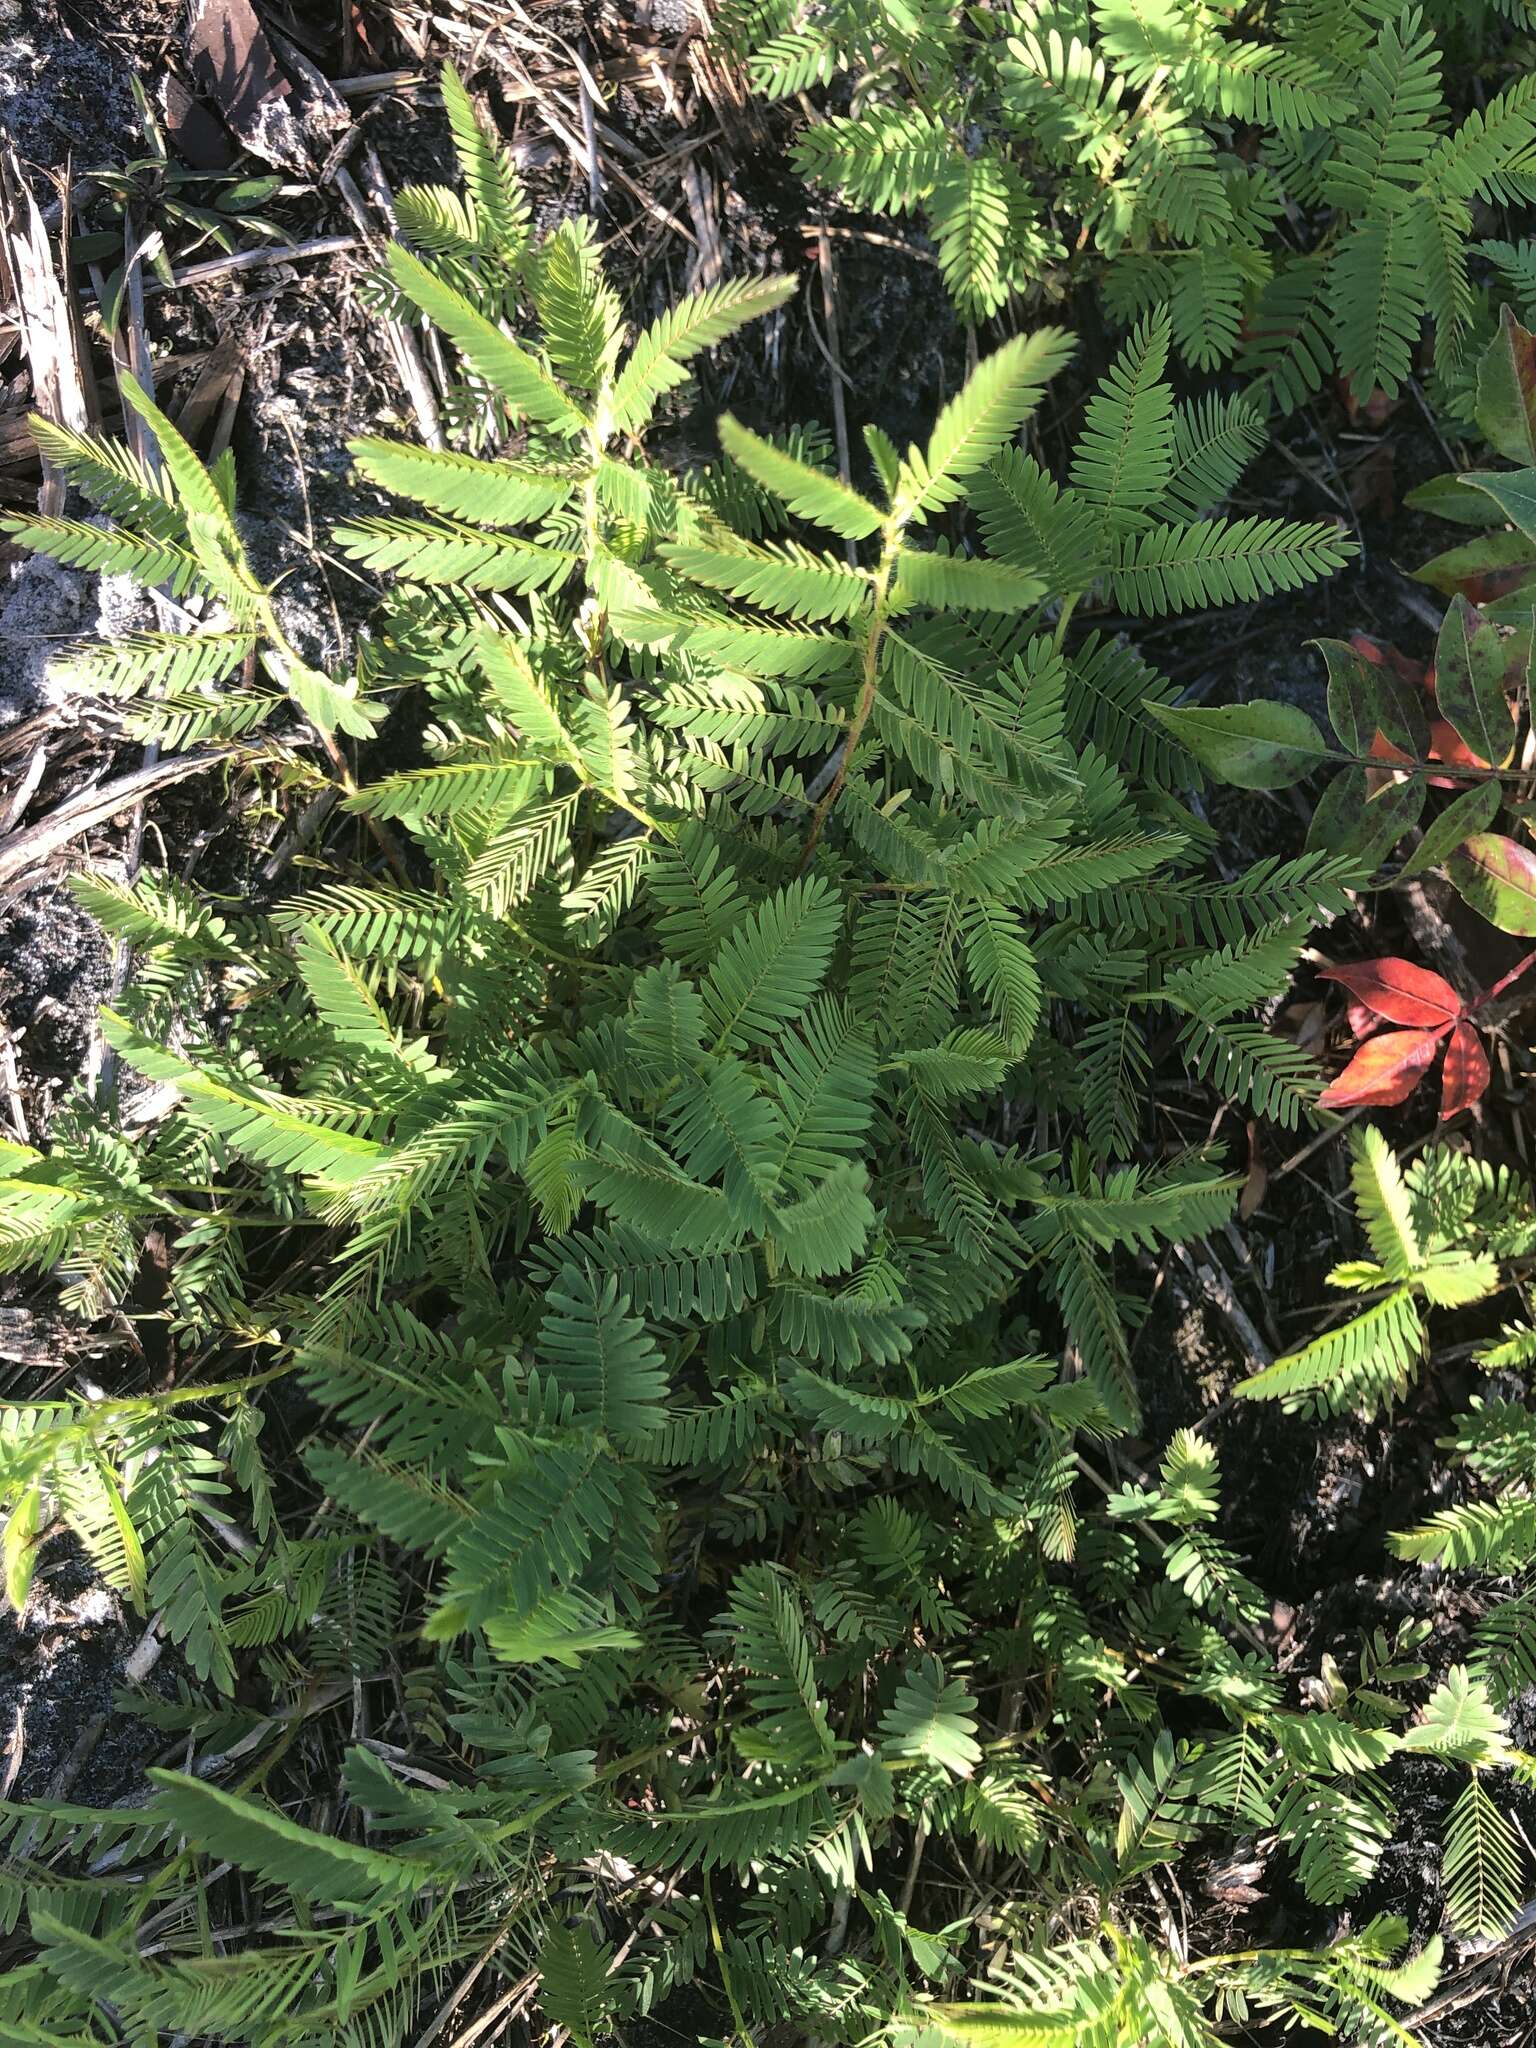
top-left (0, 64), bottom-right (1520, 2048)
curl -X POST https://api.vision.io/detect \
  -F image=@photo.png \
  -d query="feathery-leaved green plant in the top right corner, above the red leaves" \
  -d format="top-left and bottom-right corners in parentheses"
top-left (721, 0), bottom-right (1536, 412)
